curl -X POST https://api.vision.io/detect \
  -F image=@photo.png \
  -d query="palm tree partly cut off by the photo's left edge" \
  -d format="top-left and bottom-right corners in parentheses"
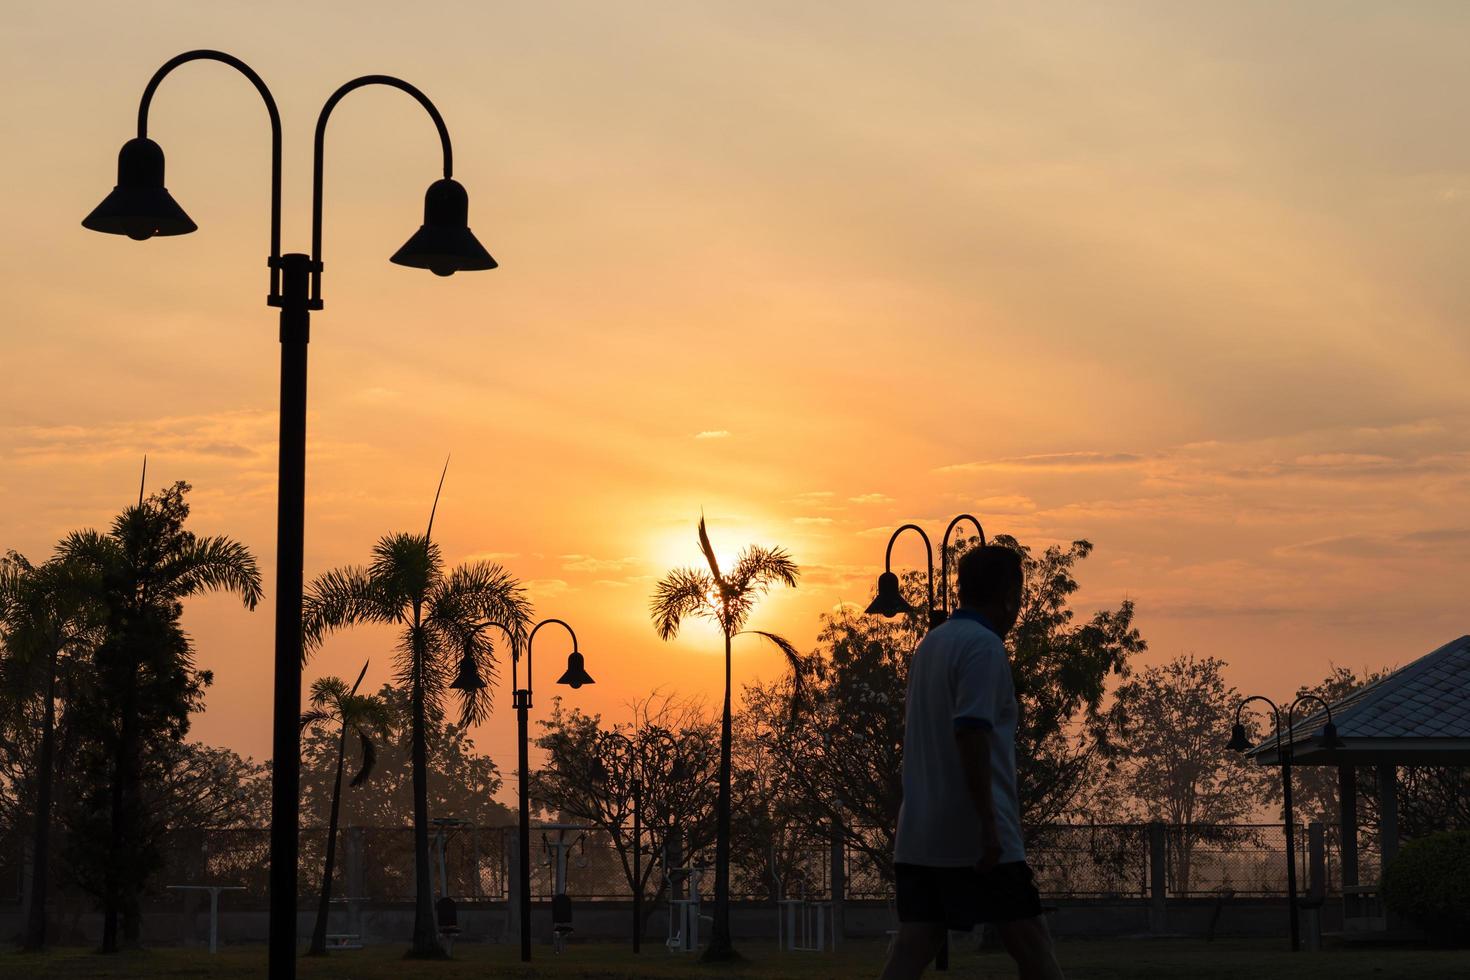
top-left (0, 551), bottom-right (100, 951)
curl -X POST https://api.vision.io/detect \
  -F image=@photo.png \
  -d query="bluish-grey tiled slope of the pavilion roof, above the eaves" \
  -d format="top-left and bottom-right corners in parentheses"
top-left (1251, 636), bottom-right (1470, 755)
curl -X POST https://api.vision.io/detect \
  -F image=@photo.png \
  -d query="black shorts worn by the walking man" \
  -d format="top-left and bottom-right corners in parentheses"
top-left (894, 861), bottom-right (1042, 932)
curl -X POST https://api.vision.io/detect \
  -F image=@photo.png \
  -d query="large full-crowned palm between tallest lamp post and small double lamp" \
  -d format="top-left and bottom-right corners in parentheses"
top-left (303, 525), bottom-right (531, 958)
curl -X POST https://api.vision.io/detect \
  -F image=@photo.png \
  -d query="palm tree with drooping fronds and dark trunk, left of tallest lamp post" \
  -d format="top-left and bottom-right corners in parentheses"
top-left (56, 480), bottom-right (262, 952)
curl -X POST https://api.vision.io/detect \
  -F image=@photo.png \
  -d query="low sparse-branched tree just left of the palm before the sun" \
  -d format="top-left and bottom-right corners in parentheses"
top-left (531, 696), bottom-right (719, 934)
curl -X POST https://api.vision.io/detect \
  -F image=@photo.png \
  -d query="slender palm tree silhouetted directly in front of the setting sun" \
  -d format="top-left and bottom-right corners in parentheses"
top-left (650, 516), bottom-right (801, 961)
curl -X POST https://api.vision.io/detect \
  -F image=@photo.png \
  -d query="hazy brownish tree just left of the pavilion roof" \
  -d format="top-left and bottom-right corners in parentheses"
top-left (1117, 654), bottom-right (1272, 893)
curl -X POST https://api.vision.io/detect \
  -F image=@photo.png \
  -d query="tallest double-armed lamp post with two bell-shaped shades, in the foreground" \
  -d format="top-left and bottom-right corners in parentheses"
top-left (82, 50), bottom-right (495, 980)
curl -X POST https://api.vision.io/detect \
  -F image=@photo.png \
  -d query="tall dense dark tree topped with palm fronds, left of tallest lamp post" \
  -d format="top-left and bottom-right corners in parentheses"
top-left (57, 480), bottom-right (260, 952)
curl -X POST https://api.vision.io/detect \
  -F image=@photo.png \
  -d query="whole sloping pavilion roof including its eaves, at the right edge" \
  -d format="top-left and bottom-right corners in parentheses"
top-left (1247, 636), bottom-right (1470, 765)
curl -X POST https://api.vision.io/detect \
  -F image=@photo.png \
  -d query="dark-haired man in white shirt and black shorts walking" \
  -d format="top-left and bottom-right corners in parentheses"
top-left (883, 545), bottom-right (1061, 980)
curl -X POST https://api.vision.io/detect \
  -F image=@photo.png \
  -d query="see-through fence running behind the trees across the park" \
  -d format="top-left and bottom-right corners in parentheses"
top-left (0, 824), bottom-right (1379, 907)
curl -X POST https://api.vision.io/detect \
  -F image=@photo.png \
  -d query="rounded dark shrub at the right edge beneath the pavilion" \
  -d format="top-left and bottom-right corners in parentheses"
top-left (1383, 830), bottom-right (1470, 945)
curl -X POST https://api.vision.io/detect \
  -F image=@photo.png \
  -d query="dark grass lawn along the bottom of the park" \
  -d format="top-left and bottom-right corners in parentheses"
top-left (0, 939), bottom-right (1470, 980)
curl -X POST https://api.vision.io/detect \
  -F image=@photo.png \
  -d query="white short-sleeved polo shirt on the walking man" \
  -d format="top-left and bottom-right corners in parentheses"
top-left (894, 610), bottom-right (1026, 867)
